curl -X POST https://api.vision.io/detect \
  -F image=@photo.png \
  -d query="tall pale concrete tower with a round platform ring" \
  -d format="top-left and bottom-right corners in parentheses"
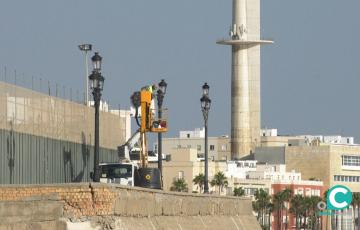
top-left (217, 0), bottom-right (272, 160)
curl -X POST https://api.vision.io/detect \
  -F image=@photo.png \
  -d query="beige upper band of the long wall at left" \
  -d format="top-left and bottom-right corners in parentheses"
top-left (0, 82), bottom-right (126, 149)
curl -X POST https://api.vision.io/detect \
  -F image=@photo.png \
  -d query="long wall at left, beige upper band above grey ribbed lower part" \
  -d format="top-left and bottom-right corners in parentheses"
top-left (0, 68), bottom-right (126, 184)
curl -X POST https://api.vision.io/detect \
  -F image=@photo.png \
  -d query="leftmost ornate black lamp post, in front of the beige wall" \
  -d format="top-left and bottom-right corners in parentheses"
top-left (89, 52), bottom-right (105, 182)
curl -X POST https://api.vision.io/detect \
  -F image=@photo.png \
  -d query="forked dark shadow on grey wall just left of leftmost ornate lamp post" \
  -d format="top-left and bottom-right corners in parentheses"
top-left (63, 132), bottom-right (90, 183)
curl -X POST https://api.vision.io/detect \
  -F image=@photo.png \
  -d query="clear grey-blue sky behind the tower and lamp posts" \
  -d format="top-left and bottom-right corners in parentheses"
top-left (0, 0), bottom-right (360, 143)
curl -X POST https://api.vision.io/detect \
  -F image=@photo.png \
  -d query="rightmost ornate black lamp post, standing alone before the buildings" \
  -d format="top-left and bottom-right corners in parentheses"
top-left (200, 83), bottom-right (211, 193)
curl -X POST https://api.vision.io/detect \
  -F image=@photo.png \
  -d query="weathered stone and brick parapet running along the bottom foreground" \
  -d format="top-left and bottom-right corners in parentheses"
top-left (0, 183), bottom-right (259, 230)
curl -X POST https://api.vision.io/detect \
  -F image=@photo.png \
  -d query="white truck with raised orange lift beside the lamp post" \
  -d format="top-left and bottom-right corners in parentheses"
top-left (100, 88), bottom-right (167, 189)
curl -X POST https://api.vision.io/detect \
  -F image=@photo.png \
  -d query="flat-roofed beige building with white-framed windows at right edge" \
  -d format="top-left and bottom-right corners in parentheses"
top-left (255, 144), bottom-right (360, 192)
